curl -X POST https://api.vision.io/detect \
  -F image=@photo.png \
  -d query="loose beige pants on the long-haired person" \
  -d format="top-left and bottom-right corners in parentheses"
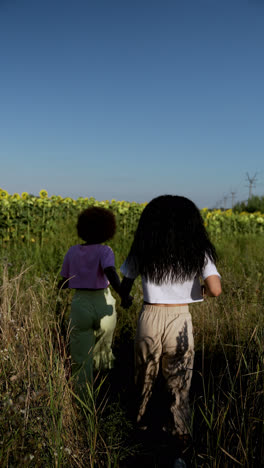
top-left (135, 304), bottom-right (194, 435)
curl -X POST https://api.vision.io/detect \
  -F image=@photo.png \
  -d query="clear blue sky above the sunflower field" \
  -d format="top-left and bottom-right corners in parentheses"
top-left (0, 0), bottom-right (264, 208)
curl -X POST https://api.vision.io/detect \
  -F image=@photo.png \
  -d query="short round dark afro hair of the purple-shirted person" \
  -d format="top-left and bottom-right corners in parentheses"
top-left (77, 206), bottom-right (116, 244)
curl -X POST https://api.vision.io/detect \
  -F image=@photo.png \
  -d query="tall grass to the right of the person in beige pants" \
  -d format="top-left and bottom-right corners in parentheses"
top-left (192, 237), bottom-right (264, 467)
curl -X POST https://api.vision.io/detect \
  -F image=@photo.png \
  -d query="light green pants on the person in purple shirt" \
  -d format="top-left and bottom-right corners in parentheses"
top-left (70, 288), bottom-right (116, 394)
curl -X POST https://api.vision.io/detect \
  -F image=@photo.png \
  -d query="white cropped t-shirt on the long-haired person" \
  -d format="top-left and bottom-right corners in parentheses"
top-left (120, 257), bottom-right (220, 304)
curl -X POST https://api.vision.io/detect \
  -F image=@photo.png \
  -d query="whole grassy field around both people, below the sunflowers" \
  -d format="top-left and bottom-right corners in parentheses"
top-left (0, 222), bottom-right (264, 468)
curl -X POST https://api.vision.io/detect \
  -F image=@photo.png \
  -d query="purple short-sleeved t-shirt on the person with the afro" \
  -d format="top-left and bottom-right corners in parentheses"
top-left (61, 244), bottom-right (115, 289)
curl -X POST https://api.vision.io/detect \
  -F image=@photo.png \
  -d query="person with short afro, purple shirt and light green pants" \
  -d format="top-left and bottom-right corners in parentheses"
top-left (59, 207), bottom-right (129, 395)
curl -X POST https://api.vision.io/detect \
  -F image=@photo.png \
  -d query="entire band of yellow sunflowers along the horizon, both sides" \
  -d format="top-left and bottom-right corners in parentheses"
top-left (0, 188), bottom-right (264, 245)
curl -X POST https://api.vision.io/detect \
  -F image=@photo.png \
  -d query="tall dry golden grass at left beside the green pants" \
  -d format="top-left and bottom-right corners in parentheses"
top-left (0, 265), bottom-right (134, 467)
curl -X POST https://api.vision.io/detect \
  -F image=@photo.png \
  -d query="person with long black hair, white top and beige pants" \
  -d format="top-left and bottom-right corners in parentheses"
top-left (121, 195), bottom-right (221, 456)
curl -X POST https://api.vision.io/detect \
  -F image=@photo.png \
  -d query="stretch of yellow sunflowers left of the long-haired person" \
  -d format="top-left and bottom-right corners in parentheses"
top-left (0, 188), bottom-right (146, 244)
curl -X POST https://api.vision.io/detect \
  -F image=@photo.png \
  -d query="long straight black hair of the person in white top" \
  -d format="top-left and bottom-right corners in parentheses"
top-left (127, 195), bottom-right (217, 284)
